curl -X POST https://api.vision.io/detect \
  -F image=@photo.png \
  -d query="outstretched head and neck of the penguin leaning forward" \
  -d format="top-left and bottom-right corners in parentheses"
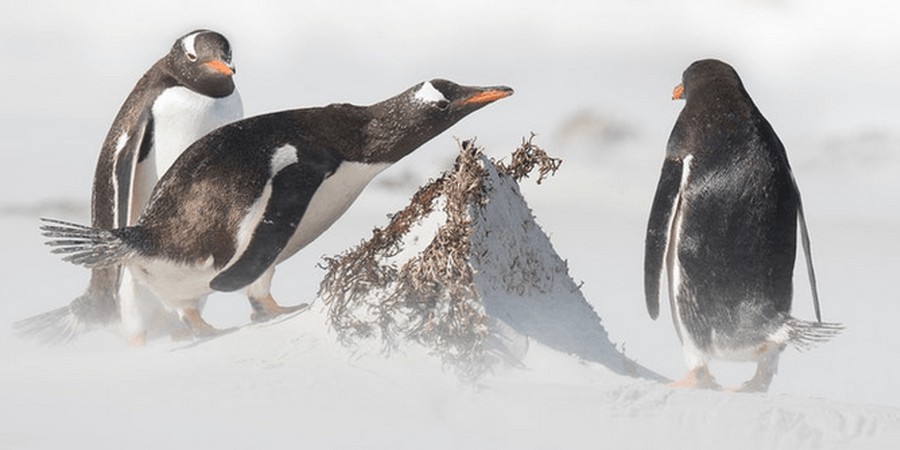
top-left (366, 79), bottom-right (513, 162)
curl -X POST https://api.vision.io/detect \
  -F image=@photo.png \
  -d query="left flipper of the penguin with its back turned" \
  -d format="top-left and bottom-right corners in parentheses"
top-left (644, 158), bottom-right (683, 319)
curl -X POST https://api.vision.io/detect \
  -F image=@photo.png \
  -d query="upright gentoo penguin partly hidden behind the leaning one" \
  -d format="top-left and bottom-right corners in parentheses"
top-left (17, 30), bottom-right (243, 344)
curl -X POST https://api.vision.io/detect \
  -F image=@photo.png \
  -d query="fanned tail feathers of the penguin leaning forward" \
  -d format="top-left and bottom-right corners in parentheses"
top-left (41, 218), bottom-right (132, 268)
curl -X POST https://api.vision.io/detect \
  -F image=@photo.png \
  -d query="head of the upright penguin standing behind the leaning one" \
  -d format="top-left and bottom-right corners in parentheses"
top-left (164, 30), bottom-right (234, 98)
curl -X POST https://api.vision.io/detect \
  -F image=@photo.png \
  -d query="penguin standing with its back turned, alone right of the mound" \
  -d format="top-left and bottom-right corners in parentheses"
top-left (644, 59), bottom-right (840, 392)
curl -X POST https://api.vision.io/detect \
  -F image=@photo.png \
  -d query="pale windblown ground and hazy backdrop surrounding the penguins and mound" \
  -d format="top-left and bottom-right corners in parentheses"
top-left (0, 0), bottom-right (900, 449)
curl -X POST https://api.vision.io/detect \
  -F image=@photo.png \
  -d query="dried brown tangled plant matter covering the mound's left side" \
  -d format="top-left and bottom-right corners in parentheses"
top-left (319, 135), bottom-right (561, 378)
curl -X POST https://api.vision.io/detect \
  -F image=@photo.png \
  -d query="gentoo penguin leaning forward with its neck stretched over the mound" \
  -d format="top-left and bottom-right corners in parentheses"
top-left (42, 79), bottom-right (513, 336)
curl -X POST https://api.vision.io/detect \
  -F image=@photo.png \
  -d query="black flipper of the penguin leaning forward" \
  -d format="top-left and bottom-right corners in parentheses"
top-left (209, 163), bottom-right (325, 292)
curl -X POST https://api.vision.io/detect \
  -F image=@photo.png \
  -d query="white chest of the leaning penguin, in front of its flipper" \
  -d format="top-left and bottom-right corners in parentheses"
top-left (276, 161), bottom-right (391, 263)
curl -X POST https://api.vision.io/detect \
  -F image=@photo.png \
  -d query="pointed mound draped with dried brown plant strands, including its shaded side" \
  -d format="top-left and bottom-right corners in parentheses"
top-left (319, 136), bottom-right (661, 379)
